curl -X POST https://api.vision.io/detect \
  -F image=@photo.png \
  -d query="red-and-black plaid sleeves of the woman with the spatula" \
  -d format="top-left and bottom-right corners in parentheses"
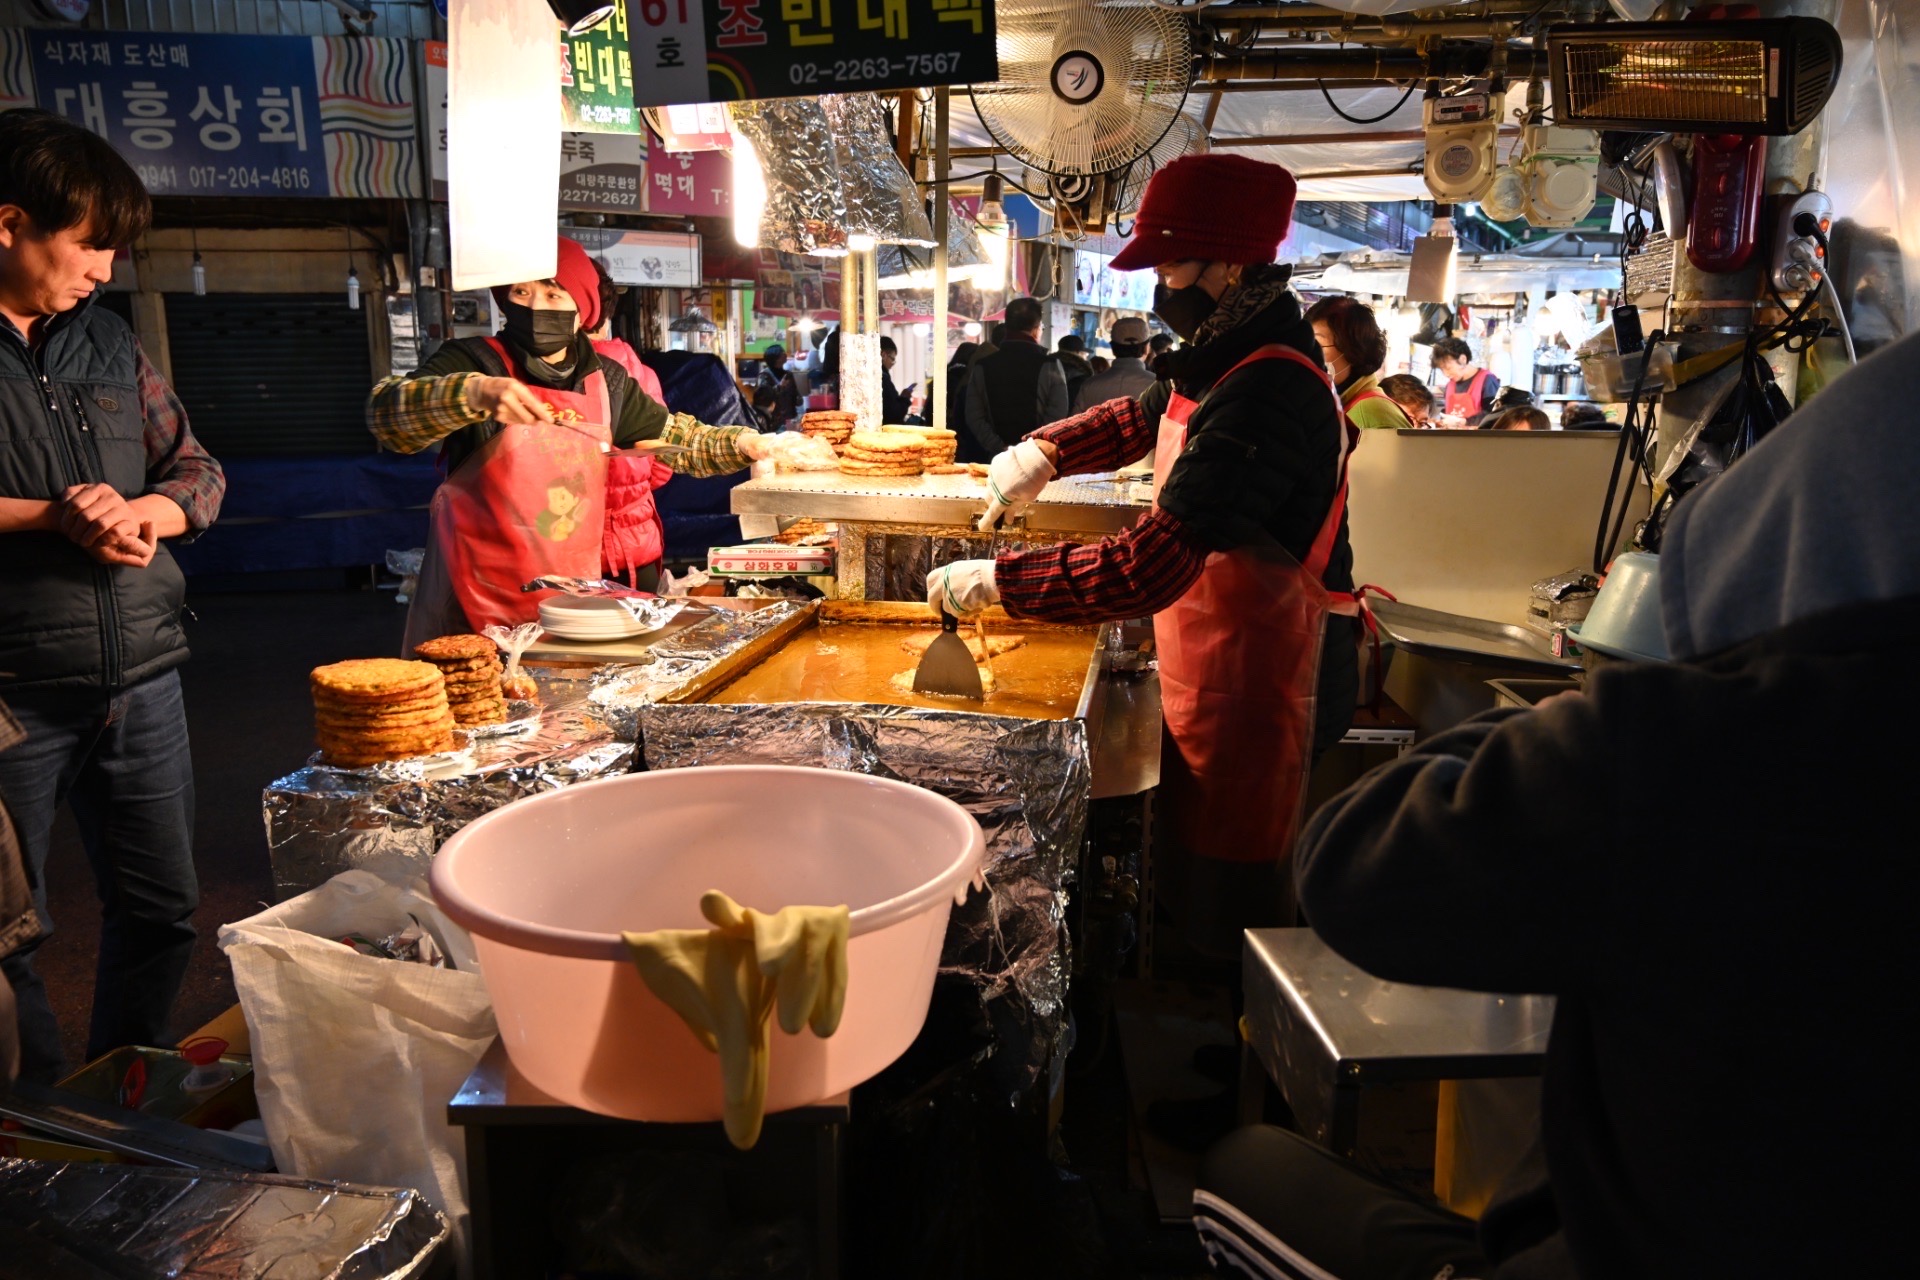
top-left (993, 399), bottom-right (1208, 624)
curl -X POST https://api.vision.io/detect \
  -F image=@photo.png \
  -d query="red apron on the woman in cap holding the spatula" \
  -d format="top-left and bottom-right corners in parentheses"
top-left (1154, 344), bottom-right (1359, 862)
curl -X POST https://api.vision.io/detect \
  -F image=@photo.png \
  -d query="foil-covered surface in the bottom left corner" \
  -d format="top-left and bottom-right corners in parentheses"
top-left (0, 1159), bottom-right (447, 1280)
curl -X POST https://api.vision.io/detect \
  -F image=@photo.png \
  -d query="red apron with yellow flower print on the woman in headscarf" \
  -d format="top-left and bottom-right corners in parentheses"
top-left (428, 338), bottom-right (612, 631)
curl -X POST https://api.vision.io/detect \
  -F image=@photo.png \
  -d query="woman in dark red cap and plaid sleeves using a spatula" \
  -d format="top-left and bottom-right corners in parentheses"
top-left (927, 154), bottom-right (1357, 956)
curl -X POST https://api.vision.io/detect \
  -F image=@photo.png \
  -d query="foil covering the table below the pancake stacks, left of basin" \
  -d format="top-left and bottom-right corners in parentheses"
top-left (261, 677), bottom-right (634, 902)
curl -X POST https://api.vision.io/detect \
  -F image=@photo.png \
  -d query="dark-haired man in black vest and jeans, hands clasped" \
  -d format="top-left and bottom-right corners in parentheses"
top-left (0, 111), bottom-right (227, 1080)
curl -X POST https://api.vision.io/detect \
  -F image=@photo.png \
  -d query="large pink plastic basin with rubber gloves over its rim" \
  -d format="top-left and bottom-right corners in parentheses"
top-left (432, 766), bottom-right (985, 1121)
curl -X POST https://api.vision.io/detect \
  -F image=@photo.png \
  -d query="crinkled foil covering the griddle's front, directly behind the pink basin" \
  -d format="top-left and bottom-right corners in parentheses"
top-left (639, 702), bottom-right (1092, 1098)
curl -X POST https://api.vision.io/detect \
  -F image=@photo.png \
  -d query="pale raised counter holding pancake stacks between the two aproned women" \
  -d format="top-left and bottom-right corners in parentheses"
top-left (733, 472), bottom-right (1154, 535)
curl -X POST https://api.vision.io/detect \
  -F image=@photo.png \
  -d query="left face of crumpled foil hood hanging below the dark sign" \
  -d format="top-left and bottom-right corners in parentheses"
top-left (732, 98), bottom-right (847, 257)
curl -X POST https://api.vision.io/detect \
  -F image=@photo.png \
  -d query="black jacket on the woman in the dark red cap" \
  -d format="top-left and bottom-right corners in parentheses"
top-left (1140, 267), bottom-right (1359, 752)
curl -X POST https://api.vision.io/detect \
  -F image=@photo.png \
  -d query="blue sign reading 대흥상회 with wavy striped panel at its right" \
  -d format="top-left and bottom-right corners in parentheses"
top-left (13, 31), bottom-right (420, 200)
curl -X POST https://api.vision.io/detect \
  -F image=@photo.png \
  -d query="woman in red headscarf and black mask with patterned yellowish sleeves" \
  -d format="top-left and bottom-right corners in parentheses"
top-left (367, 236), bottom-right (766, 652)
